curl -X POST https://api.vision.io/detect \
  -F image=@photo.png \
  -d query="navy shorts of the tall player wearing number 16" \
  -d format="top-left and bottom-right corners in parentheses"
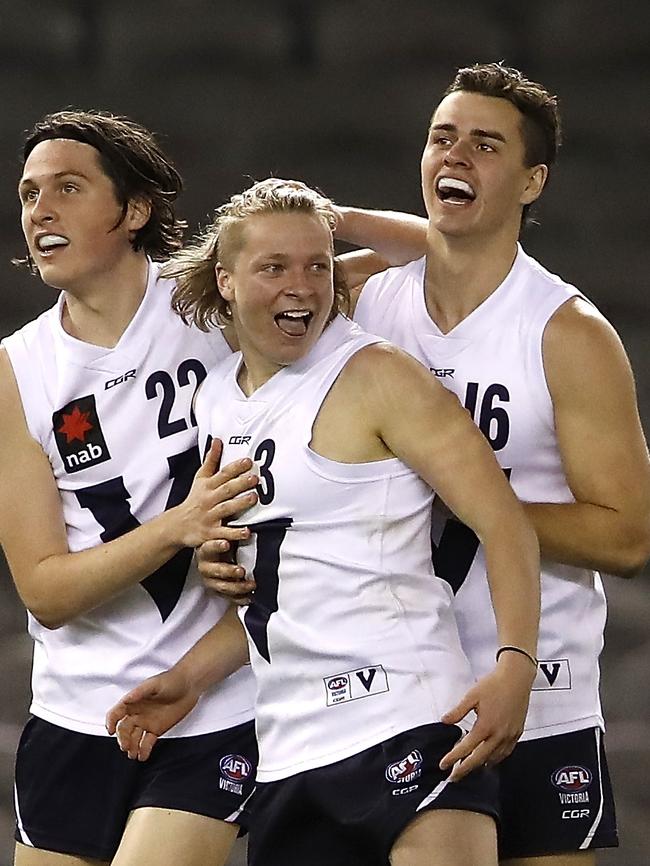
top-left (497, 728), bottom-right (618, 859)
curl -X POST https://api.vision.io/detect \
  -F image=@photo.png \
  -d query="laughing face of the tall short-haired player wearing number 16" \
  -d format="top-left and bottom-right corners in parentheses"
top-left (421, 91), bottom-right (547, 238)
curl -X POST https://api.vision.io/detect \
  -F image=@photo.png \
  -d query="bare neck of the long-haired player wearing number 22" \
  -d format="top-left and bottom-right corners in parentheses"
top-left (61, 253), bottom-right (148, 349)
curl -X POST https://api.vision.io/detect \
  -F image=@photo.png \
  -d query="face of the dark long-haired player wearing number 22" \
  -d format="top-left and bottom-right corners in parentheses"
top-left (18, 139), bottom-right (148, 292)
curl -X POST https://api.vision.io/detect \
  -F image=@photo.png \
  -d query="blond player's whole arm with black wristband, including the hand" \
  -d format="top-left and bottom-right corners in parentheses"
top-left (342, 344), bottom-right (540, 778)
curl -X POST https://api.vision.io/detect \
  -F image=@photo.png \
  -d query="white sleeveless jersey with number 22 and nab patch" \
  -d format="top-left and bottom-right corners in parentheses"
top-left (3, 263), bottom-right (254, 736)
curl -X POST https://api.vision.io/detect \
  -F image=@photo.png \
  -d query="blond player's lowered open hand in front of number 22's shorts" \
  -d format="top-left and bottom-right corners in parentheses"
top-left (106, 668), bottom-right (195, 761)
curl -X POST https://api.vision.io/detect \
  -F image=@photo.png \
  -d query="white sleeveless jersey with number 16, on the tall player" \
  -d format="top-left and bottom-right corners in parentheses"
top-left (355, 248), bottom-right (606, 739)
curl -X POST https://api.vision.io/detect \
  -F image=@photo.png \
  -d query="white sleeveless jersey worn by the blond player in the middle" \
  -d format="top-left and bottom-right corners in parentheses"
top-left (196, 317), bottom-right (473, 782)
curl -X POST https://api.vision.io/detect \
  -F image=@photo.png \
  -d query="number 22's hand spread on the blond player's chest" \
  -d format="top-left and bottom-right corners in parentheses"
top-left (175, 439), bottom-right (259, 553)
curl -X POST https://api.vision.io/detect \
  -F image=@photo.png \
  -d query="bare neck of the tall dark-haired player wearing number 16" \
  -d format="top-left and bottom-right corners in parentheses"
top-left (425, 227), bottom-right (517, 333)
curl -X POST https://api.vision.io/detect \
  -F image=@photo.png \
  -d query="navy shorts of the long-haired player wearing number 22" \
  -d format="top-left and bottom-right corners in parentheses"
top-left (15, 718), bottom-right (257, 860)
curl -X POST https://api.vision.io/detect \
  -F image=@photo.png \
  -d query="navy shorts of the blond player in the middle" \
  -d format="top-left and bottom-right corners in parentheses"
top-left (248, 724), bottom-right (497, 866)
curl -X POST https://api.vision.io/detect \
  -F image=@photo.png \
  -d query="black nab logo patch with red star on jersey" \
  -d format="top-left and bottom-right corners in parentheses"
top-left (52, 394), bottom-right (111, 472)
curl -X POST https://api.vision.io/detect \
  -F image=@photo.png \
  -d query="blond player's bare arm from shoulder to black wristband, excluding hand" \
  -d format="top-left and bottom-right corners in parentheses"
top-left (363, 346), bottom-right (539, 655)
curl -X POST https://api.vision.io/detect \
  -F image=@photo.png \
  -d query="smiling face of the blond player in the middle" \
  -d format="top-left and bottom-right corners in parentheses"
top-left (217, 211), bottom-right (334, 387)
